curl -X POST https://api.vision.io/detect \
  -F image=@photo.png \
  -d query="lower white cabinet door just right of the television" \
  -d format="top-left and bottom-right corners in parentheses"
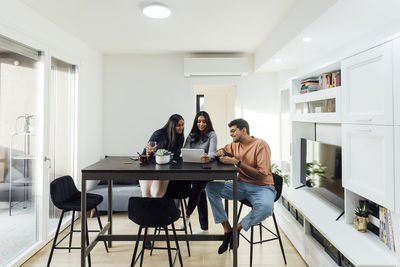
top-left (342, 124), bottom-right (394, 210)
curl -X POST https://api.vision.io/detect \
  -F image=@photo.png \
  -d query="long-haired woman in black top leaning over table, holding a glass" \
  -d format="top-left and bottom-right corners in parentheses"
top-left (139, 114), bottom-right (184, 197)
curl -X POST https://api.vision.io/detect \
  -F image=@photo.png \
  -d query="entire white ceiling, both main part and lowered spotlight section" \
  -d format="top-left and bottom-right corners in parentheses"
top-left (20, 0), bottom-right (400, 71)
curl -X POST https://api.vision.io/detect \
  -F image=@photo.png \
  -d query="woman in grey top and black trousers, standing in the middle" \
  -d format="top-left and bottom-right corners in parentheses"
top-left (181, 111), bottom-right (217, 233)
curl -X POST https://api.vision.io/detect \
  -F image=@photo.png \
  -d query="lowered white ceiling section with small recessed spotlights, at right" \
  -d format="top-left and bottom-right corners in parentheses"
top-left (257, 0), bottom-right (400, 72)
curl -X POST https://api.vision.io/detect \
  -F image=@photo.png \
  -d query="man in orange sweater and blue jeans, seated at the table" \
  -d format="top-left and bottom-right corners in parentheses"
top-left (206, 119), bottom-right (276, 254)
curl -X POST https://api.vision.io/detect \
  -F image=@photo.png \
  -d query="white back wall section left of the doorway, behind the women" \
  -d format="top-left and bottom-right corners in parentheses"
top-left (104, 55), bottom-right (193, 155)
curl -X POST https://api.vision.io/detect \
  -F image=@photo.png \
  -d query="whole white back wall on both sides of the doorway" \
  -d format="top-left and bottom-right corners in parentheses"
top-left (104, 55), bottom-right (279, 162)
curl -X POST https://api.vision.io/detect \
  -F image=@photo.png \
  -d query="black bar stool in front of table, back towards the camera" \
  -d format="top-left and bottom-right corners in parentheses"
top-left (128, 197), bottom-right (183, 267)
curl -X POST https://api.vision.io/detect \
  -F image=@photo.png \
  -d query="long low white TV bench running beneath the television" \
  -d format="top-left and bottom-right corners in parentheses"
top-left (275, 187), bottom-right (397, 266)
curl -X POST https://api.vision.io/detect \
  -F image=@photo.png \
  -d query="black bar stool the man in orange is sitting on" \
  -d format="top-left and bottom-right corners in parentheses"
top-left (238, 173), bottom-right (286, 267)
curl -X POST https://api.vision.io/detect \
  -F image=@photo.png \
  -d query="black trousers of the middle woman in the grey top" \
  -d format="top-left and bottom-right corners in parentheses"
top-left (186, 181), bottom-right (209, 230)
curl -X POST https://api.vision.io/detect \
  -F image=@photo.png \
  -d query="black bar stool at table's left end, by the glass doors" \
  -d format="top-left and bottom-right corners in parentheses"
top-left (47, 175), bottom-right (108, 266)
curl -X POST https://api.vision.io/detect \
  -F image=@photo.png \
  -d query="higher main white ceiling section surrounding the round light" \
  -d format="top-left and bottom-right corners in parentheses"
top-left (22, 0), bottom-right (296, 54)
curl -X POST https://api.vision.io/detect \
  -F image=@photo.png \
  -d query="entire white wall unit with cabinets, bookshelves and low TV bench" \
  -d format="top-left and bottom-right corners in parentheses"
top-left (284, 38), bottom-right (400, 266)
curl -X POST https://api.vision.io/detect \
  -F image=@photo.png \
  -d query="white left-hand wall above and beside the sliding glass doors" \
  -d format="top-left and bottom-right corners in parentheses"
top-left (0, 0), bottom-right (103, 182)
